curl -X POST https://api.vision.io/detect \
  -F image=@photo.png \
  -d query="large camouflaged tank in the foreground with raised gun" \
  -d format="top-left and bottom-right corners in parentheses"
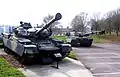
top-left (3, 13), bottom-right (72, 64)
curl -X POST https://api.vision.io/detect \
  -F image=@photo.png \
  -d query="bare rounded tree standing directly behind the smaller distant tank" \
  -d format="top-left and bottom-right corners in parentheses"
top-left (71, 12), bottom-right (88, 33)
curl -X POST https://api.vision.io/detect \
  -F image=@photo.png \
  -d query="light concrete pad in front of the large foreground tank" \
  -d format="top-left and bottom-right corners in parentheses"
top-left (19, 58), bottom-right (93, 77)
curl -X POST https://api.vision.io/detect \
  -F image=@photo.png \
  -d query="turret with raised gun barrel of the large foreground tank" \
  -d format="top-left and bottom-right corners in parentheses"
top-left (14, 13), bottom-right (62, 39)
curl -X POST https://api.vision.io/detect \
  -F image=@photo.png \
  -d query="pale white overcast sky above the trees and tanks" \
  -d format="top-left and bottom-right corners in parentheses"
top-left (0, 0), bottom-right (120, 27)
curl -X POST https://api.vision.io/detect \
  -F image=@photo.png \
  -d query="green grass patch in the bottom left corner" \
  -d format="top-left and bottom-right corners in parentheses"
top-left (0, 57), bottom-right (25, 77)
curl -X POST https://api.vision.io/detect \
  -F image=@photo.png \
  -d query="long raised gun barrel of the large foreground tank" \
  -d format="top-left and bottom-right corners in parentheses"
top-left (35, 13), bottom-right (62, 35)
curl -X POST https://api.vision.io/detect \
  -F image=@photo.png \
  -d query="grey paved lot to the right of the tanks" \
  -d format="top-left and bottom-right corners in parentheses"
top-left (73, 43), bottom-right (120, 77)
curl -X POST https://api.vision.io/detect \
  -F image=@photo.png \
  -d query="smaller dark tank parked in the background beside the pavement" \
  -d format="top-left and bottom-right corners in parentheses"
top-left (66, 31), bottom-right (94, 47)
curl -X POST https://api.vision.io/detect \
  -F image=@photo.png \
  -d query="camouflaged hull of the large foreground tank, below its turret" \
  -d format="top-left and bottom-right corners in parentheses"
top-left (3, 37), bottom-right (72, 64)
